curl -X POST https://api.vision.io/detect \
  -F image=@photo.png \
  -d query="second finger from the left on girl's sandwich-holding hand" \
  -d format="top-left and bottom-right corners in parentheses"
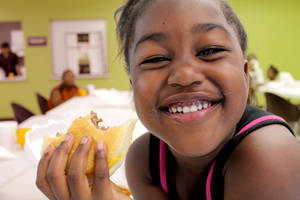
top-left (47, 134), bottom-right (73, 200)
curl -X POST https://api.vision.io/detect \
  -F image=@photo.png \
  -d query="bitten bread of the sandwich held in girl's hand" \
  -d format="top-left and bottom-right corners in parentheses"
top-left (42, 113), bottom-right (137, 176)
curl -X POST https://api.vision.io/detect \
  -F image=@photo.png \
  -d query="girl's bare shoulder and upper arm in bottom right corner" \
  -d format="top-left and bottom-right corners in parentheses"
top-left (224, 125), bottom-right (300, 200)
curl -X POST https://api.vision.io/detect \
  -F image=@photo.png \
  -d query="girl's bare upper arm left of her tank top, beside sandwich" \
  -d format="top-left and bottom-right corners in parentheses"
top-left (126, 133), bottom-right (168, 200)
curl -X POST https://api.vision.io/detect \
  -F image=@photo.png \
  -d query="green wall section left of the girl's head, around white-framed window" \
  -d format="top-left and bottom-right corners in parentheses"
top-left (0, 0), bottom-right (130, 118)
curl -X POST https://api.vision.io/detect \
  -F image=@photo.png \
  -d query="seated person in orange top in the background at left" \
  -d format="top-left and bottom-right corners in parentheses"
top-left (48, 70), bottom-right (86, 110)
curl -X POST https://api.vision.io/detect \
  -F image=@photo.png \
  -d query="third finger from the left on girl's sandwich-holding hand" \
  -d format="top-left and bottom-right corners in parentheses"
top-left (68, 136), bottom-right (91, 199)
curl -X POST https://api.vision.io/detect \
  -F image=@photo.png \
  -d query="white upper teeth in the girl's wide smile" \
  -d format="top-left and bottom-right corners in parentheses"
top-left (169, 101), bottom-right (211, 113)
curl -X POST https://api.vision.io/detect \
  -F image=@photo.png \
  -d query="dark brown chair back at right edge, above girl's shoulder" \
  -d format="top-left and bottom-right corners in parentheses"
top-left (265, 92), bottom-right (300, 123)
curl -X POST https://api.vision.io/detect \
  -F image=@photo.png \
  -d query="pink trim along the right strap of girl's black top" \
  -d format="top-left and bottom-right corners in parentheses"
top-left (206, 115), bottom-right (285, 200)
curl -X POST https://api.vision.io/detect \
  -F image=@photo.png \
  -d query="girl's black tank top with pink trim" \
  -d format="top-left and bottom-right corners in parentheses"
top-left (149, 106), bottom-right (294, 200)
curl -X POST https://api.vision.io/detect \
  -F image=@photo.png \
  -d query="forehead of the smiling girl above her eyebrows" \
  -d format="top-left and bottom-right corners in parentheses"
top-left (133, 0), bottom-right (234, 40)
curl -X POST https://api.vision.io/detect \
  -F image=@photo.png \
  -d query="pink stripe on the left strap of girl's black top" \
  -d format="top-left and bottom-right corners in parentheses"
top-left (159, 140), bottom-right (169, 194)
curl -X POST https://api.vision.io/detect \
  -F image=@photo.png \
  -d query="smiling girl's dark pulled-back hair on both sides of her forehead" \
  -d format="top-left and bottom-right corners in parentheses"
top-left (115, 0), bottom-right (248, 72)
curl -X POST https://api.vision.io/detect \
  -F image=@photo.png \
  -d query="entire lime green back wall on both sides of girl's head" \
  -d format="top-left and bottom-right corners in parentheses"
top-left (0, 0), bottom-right (300, 118)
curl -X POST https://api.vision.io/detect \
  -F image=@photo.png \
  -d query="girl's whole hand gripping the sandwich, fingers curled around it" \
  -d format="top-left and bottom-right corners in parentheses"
top-left (36, 134), bottom-right (130, 200)
